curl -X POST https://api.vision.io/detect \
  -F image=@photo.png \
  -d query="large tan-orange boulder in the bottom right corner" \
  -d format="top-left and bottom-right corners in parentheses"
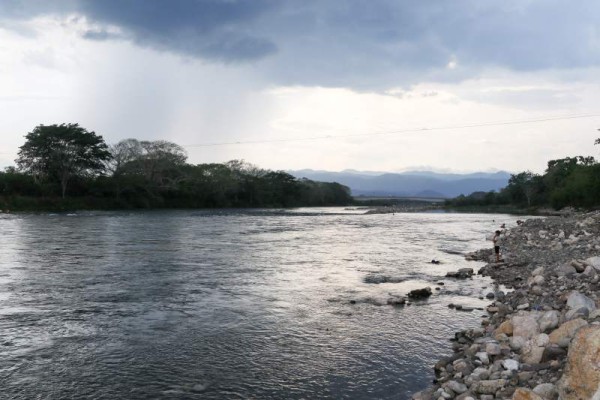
top-left (558, 326), bottom-right (600, 400)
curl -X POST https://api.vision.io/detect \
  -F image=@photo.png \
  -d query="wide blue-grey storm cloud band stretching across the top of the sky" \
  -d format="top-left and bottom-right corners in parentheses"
top-left (0, 0), bottom-right (600, 88)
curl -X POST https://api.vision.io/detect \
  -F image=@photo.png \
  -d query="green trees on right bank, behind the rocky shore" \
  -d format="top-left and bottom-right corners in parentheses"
top-left (446, 139), bottom-right (600, 209)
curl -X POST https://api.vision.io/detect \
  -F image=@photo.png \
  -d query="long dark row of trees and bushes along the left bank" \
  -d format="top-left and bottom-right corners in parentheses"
top-left (0, 124), bottom-right (352, 209)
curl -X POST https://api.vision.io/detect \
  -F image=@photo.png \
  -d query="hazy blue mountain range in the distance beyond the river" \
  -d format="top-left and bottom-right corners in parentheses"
top-left (287, 169), bottom-right (511, 198)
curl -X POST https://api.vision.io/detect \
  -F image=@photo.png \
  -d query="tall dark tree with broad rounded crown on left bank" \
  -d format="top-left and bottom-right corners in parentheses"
top-left (16, 124), bottom-right (111, 198)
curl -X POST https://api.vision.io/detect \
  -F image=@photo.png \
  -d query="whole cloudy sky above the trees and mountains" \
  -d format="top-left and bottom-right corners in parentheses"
top-left (0, 0), bottom-right (600, 173)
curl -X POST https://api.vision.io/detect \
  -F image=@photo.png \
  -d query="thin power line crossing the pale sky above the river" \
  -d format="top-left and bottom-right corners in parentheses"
top-left (183, 114), bottom-right (600, 147)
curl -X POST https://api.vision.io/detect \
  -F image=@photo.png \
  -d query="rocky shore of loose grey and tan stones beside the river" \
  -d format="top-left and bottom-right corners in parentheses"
top-left (412, 212), bottom-right (600, 400)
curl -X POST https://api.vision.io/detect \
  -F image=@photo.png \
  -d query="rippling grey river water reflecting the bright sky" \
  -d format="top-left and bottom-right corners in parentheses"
top-left (0, 208), bottom-right (514, 399)
